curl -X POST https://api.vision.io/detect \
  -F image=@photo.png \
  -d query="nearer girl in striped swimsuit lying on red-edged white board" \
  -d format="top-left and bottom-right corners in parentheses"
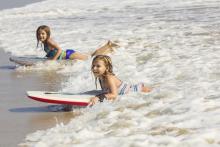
top-left (89, 55), bottom-right (151, 105)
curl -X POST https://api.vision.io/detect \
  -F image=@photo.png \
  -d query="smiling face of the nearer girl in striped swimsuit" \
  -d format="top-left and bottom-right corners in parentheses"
top-left (92, 60), bottom-right (107, 77)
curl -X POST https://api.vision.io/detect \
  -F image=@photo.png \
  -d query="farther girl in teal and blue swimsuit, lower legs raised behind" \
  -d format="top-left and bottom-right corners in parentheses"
top-left (36, 25), bottom-right (119, 60)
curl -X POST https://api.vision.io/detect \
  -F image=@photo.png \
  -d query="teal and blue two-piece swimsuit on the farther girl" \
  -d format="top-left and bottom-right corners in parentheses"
top-left (44, 44), bottom-right (76, 60)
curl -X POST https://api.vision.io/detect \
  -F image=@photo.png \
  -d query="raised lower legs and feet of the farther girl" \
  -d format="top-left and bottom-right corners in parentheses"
top-left (91, 40), bottom-right (119, 56)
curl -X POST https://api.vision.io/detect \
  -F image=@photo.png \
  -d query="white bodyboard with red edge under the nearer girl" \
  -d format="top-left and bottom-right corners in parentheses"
top-left (27, 91), bottom-right (100, 106)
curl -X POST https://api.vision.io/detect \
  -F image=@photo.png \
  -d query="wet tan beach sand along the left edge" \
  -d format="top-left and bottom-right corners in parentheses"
top-left (0, 0), bottom-right (73, 147)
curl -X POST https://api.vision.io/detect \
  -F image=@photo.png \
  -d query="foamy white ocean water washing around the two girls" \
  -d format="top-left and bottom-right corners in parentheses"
top-left (0, 0), bottom-right (220, 147)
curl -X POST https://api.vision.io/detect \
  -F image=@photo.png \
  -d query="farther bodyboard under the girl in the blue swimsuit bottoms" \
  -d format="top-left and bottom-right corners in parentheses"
top-left (9, 56), bottom-right (47, 66)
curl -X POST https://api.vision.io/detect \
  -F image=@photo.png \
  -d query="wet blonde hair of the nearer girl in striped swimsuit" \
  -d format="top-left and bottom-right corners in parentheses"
top-left (91, 55), bottom-right (115, 89)
